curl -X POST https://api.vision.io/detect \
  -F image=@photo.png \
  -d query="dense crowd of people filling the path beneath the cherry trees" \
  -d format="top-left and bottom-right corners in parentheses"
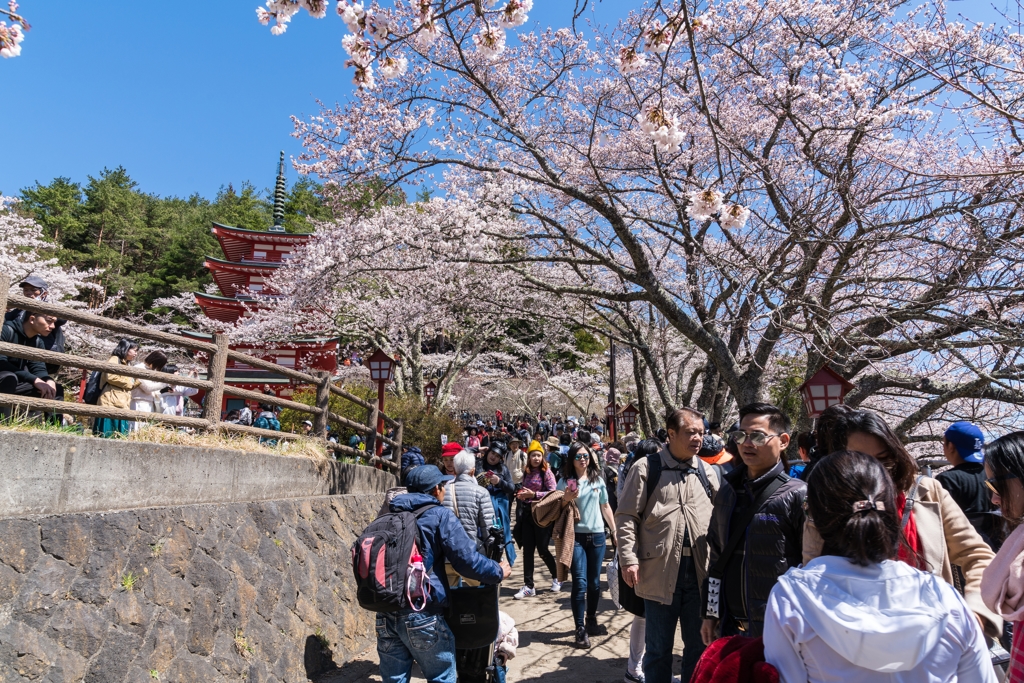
top-left (382, 403), bottom-right (1024, 683)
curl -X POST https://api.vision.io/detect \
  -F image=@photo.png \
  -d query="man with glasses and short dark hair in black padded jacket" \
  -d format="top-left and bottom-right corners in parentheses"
top-left (700, 403), bottom-right (807, 645)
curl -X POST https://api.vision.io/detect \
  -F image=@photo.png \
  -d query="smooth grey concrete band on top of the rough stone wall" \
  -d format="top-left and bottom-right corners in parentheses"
top-left (0, 430), bottom-right (395, 518)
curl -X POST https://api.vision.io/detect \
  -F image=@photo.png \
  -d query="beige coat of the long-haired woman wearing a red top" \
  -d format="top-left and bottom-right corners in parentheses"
top-left (804, 477), bottom-right (1002, 638)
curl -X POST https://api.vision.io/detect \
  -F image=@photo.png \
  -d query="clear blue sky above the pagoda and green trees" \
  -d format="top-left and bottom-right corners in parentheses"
top-left (0, 0), bottom-right (1009, 198)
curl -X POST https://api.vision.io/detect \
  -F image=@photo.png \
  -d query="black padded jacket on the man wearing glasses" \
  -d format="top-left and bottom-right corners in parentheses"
top-left (702, 462), bottom-right (807, 638)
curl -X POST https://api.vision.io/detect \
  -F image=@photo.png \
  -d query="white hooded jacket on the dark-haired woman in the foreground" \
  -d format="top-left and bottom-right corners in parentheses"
top-left (764, 555), bottom-right (996, 683)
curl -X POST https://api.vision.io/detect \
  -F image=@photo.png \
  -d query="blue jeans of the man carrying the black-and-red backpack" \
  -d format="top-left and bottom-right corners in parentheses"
top-left (377, 609), bottom-right (456, 683)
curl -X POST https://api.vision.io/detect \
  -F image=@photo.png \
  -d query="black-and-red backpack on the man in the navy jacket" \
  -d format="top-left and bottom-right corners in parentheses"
top-left (352, 504), bottom-right (436, 612)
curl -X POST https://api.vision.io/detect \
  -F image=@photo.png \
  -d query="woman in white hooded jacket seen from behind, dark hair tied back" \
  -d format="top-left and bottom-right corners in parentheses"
top-left (764, 451), bottom-right (996, 683)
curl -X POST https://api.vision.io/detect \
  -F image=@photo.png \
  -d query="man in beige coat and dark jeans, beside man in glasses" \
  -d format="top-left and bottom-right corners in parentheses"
top-left (615, 408), bottom-right (719, 683)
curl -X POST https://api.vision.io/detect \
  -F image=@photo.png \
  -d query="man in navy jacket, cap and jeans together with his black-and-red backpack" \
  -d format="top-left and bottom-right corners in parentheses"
top-left (368, 465), bottom-right (512, 683)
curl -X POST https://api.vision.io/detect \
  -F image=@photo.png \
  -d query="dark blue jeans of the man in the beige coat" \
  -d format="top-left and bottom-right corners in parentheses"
top-left (643, 556), bottom-right (705, 683)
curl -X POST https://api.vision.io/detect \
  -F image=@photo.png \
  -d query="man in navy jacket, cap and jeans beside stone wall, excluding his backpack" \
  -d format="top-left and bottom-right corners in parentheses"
top-left (377, 465), bottom-right (512, 683)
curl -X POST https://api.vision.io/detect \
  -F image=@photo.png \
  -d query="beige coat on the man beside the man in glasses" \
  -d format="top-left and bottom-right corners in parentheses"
top-left (615, 449), bottom-right (719, 604)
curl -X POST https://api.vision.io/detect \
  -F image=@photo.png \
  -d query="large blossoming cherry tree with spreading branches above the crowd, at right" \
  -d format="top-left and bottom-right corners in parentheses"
top-left (260, 0), bottom-right (1024, 438)
